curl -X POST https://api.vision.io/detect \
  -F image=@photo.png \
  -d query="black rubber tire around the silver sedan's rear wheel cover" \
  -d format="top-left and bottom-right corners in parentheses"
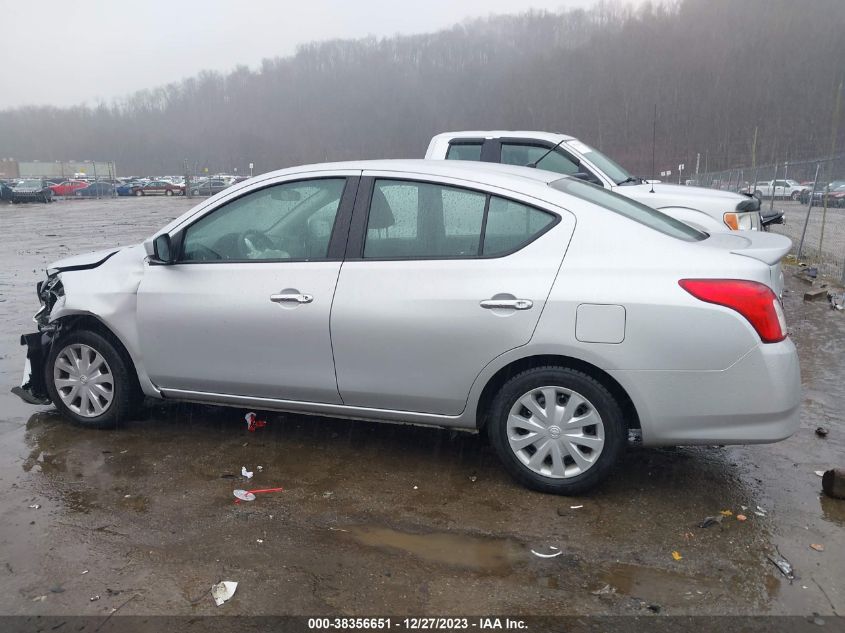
top-left (487, 366), bottom-right (627, 495)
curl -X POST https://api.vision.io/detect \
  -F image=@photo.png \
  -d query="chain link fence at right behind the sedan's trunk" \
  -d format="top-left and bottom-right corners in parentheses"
top-left (698, 154), bottom-right (845, 284)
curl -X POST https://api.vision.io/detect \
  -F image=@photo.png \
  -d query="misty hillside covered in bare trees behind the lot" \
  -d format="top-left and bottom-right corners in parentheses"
top-left (0, 0), bottom-right (845, 174)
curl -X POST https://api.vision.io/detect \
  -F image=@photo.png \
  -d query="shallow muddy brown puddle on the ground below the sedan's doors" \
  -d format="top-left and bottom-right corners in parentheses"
top-left (345, 526), bottom-right (527, 573)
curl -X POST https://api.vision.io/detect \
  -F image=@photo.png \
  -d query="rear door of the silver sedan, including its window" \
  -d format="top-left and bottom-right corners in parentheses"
top-left (331, 172), bottom-right (574, 415)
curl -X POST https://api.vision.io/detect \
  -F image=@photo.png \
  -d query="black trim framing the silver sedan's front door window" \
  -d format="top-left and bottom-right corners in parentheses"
top-left (170, 172), bottom-right (361, 266)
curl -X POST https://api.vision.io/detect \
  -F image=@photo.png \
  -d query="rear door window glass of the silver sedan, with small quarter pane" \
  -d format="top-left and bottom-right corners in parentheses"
top-left (364, 180), bottom-right (557, 259)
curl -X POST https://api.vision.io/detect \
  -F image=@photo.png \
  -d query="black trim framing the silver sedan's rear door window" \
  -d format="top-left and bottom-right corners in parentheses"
top-left (344, 174), bottom-right (562, 262)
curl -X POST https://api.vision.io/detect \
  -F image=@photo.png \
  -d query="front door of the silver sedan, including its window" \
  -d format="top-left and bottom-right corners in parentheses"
top-left (138, 171), bottom-right (358, 403)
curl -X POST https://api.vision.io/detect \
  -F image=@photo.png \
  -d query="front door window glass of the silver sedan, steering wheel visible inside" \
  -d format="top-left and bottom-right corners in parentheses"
top-left (182, 178), bottom-right (346, 262)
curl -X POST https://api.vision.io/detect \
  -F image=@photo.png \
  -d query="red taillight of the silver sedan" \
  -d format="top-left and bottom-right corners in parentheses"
top-left (678, 279), bottom-right (786, 343)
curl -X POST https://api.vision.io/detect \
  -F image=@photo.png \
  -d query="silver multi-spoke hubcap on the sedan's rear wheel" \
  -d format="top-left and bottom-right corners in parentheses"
top-left (507, 387), bottom-right (604, 479)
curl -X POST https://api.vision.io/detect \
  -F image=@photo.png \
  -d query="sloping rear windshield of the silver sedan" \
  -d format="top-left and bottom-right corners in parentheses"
top-left (549, 178), bottom-right (707, 242)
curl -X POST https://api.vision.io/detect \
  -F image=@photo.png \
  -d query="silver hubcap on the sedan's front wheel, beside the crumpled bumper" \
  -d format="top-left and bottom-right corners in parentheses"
top-left (53, 343), bottom-right (114, 418)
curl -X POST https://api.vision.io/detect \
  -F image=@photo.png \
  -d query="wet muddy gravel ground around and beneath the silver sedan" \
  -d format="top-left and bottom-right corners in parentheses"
top-left (0, 198), bottom-right (845, 616)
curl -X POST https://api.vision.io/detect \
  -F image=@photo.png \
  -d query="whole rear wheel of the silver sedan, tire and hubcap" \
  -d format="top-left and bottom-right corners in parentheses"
top-left (487, 367), bottom-right (627, 495)
